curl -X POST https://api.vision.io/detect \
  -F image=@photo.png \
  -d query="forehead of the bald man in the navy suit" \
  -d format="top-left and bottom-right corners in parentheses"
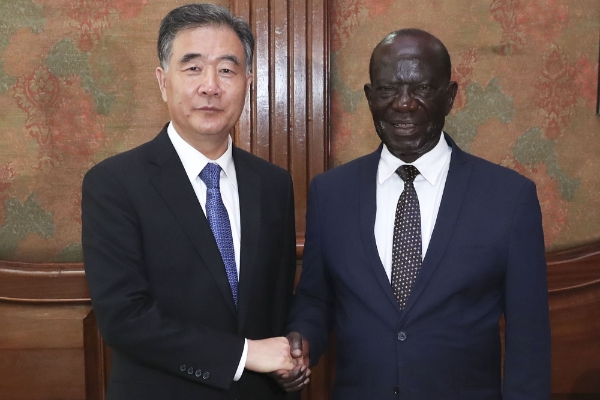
top-left (372, 36), bottom-right (443, 79)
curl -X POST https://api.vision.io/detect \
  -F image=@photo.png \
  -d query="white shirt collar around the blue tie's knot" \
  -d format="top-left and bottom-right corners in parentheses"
top-left (167, 122), bottom-right (237, 189)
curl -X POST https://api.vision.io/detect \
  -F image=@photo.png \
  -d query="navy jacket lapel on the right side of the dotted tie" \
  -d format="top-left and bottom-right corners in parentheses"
top-left (402, 134), bottom-right (472, 321)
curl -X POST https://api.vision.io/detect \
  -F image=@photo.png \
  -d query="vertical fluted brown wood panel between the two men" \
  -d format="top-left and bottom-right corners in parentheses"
top-left (231, 0), bottom-right (329, 250)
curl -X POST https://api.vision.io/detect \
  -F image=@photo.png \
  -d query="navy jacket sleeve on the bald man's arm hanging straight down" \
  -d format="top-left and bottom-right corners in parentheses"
top-left (503, 181), bottom-right (551, 400)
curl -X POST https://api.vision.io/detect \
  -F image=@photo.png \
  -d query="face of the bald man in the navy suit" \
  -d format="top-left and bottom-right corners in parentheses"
top-left (365, 36), bottom-right (457, 162)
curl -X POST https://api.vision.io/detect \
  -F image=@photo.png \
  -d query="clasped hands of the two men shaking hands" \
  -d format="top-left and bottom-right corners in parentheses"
top-left (245, 332), bottom-right (310, 392)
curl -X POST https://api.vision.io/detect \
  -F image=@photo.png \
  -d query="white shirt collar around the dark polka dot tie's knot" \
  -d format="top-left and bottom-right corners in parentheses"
top-left (377, 132), bottom-right (452, 185)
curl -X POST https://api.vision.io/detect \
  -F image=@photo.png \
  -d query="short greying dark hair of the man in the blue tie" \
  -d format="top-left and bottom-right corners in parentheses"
top-left (156, 4), bottom-right (254, 72)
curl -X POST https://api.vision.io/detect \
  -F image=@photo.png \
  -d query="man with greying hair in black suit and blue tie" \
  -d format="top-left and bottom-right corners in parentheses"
top-left (82, 4), bottom-right (302, 400)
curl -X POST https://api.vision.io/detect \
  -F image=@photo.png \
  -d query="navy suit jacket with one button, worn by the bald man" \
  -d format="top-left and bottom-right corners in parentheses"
top-left (288, 136), bottom-right (550, 400)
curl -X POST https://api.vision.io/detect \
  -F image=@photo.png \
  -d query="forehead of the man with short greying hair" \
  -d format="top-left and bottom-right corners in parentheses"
top-left (172, 26), bottom-right (244, 61)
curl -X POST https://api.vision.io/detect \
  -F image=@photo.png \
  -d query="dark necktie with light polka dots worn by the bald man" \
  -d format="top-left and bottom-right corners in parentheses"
top-left (392, 165), bottom-right (422, 310)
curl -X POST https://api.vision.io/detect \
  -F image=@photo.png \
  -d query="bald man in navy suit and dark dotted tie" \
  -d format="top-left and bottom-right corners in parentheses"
top-left (281, 29), bottom-right (550, 400)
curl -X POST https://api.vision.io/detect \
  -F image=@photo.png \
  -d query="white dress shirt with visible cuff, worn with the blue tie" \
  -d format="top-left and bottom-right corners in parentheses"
top-left (167, 122), bottom-right (248, 381)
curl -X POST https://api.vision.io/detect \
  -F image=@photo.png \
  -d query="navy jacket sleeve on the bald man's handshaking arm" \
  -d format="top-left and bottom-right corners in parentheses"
top-left (286, 179), bottom-right (334, 365)
